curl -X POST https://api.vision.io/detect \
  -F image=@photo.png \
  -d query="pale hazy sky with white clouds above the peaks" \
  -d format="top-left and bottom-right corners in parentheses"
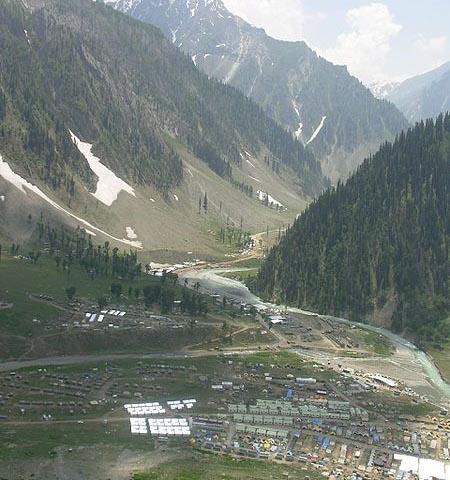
top-left (224, 0), bottom-right (450, 83)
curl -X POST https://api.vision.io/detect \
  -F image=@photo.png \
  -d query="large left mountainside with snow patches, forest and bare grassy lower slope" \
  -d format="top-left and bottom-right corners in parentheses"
top-left (0, 0), bottom-right (328, 250)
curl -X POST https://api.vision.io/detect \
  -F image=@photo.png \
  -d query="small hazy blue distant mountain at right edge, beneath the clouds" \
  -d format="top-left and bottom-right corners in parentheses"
top-left (386, 62), bottom-right (450, 122)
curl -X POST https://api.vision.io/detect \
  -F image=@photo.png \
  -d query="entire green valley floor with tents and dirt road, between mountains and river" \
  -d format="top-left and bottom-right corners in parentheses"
top-left (0, 238), bottom-right (450, 480)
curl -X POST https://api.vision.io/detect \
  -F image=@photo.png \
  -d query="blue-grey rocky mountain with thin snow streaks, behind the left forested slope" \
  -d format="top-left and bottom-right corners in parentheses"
top-left (104, 0), bottom-right (408, 181)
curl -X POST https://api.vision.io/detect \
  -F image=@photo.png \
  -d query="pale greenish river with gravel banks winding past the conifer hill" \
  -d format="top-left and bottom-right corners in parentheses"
top-left (180, 268), bottom-right (450, 409)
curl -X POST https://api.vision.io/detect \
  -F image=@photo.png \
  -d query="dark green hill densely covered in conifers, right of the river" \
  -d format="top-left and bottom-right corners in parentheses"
top-left (255, 114), bottom-right (450, 339)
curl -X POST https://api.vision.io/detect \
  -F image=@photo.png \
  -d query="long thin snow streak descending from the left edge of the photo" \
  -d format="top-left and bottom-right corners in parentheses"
top-left (0, 155), bottom-right (142, 248)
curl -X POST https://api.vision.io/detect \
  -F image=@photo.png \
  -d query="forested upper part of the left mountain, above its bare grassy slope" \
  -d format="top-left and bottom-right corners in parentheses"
top-left (0, 0), bottom-right (327, 249)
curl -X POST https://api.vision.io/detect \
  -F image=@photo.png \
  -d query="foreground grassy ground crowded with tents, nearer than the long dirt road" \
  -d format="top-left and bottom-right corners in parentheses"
top-left (0, 349), bottom-right (446, 480)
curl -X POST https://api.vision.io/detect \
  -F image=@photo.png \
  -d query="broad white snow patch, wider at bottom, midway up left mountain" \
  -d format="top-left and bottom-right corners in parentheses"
top-left (69, 130), bottom-right (136, 207)
